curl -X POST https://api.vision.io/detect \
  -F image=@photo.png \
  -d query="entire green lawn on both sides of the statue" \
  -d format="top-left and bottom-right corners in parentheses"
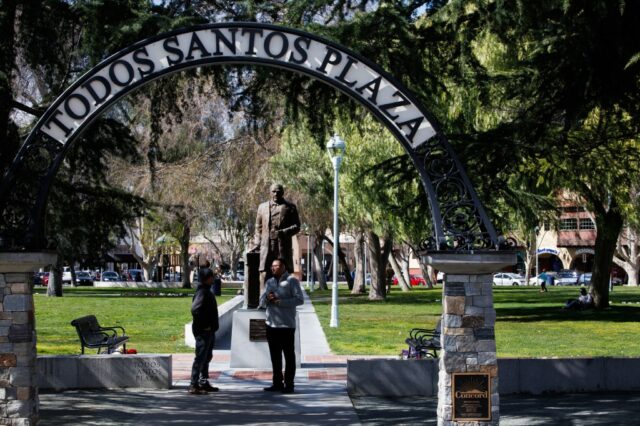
top-left (34, 287), bottom-right (640, 357)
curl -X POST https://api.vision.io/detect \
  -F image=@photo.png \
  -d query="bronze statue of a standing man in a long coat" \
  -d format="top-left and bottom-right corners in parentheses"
top-left (252, 183), bottom-right (300, 294)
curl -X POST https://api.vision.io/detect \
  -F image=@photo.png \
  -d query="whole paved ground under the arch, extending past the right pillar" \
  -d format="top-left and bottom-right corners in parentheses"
top-left (40, 295), bottom-right (640, 426)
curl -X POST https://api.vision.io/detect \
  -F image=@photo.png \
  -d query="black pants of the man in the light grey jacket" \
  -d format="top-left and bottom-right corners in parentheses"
top-left (267, 326), bottom-right (296, 388)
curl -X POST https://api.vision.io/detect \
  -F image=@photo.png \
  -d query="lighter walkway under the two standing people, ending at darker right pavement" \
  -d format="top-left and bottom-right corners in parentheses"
top-left (40, 288), bottom-right (360, 425)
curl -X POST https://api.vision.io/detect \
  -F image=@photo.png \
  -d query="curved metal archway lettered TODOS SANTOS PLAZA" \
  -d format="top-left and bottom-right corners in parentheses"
top-left (0, 22), bottom-right (502, 251)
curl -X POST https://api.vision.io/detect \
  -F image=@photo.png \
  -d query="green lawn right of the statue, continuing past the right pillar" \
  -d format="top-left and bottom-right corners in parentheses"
top-left (311, 287), bottom-right (640, 357)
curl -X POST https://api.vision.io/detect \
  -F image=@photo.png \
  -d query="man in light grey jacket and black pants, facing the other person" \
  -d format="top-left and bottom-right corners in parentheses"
top-left (260, 259), bottom-right (304, 393)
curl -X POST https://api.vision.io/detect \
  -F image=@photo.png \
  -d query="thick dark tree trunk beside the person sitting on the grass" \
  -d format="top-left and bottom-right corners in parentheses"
top-left (591, 205), bottom-right (623, 309)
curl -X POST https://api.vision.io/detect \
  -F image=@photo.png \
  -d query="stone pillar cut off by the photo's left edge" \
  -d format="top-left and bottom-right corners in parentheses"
top-left (0, 253), bottom-right (56, 425)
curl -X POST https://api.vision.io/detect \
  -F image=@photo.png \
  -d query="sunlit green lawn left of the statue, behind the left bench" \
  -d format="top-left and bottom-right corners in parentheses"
top-left (33, 287), bottom-right (237, 355)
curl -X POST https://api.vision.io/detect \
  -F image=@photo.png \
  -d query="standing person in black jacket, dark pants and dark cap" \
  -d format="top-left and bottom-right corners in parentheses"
top-left (189, 268), bottom-right (218, 395)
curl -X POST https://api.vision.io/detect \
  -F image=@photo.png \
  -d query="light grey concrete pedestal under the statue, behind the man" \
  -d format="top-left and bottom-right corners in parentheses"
top-left (229, 309), bottom-right (301, 370)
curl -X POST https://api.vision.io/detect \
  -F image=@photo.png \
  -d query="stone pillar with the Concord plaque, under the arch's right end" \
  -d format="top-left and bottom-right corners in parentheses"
top-left (423, 252), bottom-right (516, 426)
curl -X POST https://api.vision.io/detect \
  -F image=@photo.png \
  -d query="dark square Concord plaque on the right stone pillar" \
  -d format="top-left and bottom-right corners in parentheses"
top-left (451, 373), bottom-right (491, 421)
